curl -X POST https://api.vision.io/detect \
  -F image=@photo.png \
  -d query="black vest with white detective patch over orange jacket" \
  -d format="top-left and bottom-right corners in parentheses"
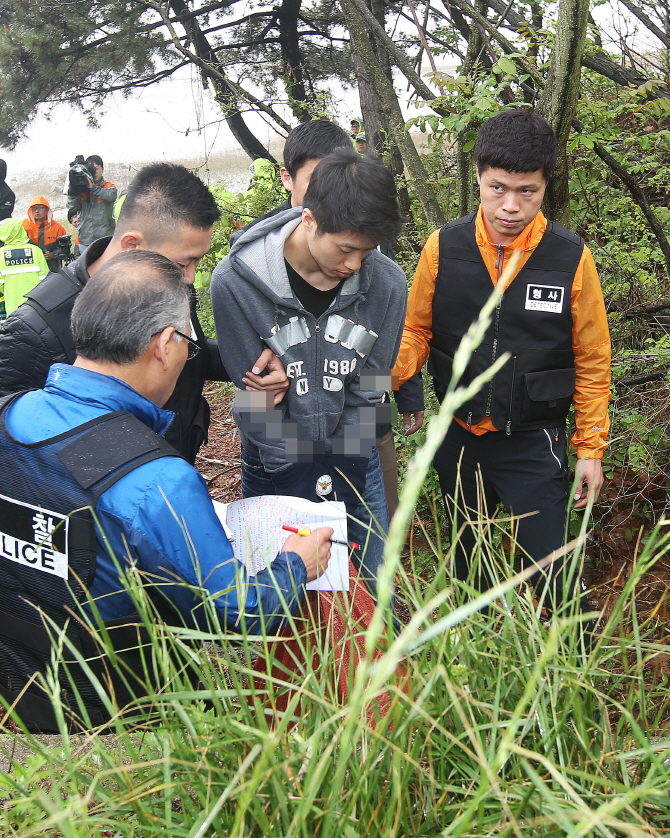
top-left (428, 215), bottom-right (584, 433)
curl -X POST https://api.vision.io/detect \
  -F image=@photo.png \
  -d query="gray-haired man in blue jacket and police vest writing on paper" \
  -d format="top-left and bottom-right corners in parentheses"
top-left (0, 251), bottom-right (332, 730)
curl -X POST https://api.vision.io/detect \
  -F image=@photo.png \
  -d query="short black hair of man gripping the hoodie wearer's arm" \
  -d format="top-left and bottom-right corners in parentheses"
top-left (115, 163), bottom-right (221, 247)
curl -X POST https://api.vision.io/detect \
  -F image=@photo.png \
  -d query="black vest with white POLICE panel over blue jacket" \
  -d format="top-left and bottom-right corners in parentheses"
top-left (0, 393), bottom-right (180, 732)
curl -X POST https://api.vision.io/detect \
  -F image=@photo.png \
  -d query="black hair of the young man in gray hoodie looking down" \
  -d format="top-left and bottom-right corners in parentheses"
top-left (302, 148), bottom-right (405, 243)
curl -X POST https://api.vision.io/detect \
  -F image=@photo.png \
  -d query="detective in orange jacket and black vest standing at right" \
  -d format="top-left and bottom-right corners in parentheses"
top-left (394, 109), bottom-right (611, 609)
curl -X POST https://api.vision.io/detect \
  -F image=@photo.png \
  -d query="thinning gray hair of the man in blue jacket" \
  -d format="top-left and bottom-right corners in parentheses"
top-left (71, 250), bottom-right (190, 364)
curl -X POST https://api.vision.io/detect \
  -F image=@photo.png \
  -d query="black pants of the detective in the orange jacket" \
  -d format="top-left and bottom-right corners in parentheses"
top-left (434, 422), bottom-right (588, 610)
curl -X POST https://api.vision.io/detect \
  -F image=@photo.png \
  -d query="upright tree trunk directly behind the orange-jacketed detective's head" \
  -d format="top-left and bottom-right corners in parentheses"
top-left (538, 0), bottom-right (589, 227)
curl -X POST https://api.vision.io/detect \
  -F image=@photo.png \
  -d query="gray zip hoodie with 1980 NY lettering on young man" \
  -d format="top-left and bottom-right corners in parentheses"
top-left (211, 207), bottom-right (407, 471)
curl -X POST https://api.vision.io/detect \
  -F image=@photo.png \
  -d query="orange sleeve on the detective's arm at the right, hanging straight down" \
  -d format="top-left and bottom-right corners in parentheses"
top-left (572, 247), bottom-right (612, 459)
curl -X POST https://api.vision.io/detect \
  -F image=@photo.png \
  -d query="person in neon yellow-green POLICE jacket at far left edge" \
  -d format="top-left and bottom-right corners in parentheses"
top-left (0, 218), bottom-right (49, 315)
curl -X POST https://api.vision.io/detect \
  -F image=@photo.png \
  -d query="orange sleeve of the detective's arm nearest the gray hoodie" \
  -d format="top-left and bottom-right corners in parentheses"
top-left (393, 230), bottom-right (440, 384)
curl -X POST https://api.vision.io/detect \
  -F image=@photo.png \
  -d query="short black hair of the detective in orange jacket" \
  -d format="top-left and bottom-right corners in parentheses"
top-left (474, 108), bottom-right (558, 180)
